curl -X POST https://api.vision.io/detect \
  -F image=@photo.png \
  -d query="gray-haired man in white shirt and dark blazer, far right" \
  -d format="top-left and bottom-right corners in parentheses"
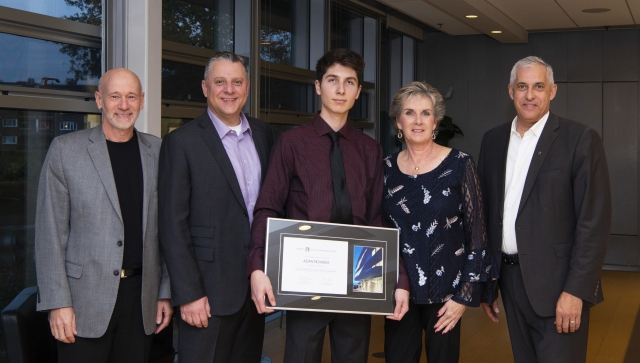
top-left (478, 57), bottom-right (611, 363)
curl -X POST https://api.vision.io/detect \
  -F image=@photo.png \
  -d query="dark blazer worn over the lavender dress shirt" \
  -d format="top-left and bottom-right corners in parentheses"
top-left (158, 112), bottom-right (274, 315)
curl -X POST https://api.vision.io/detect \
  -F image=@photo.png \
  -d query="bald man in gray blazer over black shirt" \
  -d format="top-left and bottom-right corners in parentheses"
top-left (36, 68), bottom-right (172, 362)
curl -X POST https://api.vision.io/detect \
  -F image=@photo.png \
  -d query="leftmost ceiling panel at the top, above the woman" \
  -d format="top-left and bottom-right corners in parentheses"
top-left (378, 0), bottom-right (478, 35)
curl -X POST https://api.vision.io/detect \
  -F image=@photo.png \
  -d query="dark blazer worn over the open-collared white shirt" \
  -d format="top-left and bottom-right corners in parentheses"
top-left (478, 114), bottom-right (611, 316)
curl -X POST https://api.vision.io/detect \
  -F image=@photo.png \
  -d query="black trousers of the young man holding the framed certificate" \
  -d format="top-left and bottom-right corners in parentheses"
top-left (284, 311), bottom-right (371, 363)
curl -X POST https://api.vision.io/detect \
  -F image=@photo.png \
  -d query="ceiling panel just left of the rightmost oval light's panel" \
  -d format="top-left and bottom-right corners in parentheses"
top-left (483, 0), bottom-right (576, 30)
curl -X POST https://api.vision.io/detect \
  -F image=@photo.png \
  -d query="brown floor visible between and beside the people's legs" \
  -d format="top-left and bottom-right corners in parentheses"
top-left (263, 271), bottom-right (640, 363)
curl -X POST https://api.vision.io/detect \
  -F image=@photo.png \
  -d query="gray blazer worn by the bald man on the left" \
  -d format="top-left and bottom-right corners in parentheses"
top-left (35, 126), bottom-right (170, 338)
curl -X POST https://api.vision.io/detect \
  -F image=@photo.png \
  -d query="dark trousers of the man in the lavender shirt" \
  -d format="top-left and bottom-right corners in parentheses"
top-left (178, 289), bottom-right (264, 363)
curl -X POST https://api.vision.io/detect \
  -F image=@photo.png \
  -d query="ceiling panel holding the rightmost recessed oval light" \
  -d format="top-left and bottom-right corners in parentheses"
top-left (556, 0), bottom-right (634, 28)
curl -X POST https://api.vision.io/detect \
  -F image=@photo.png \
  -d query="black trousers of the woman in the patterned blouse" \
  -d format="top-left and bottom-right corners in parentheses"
top-left (384, 301), bottom-right (462, 363)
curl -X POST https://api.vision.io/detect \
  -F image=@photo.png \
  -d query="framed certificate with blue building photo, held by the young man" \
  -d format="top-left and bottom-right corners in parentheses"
top-left (265, 218), bottom-right (399, 315)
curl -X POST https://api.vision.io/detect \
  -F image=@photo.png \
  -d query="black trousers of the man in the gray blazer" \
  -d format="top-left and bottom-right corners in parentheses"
top-left (58, 275), bottom-right (153, 363)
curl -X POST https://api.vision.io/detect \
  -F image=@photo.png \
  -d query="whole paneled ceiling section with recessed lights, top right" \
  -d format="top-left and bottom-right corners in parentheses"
top-left (378, 0), bottom-right (640, 43)
